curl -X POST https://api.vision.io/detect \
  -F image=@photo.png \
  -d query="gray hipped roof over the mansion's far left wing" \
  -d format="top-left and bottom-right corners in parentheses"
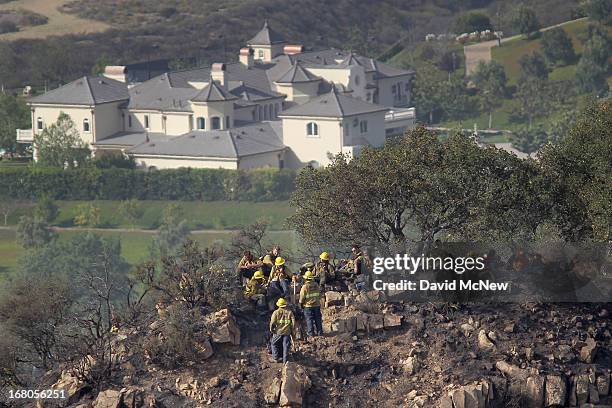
top-left (30, 76), bottom-right (129, 105)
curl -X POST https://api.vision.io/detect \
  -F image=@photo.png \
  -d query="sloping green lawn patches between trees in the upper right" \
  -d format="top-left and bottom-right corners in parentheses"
top-left (491, 20), bottom-right (612, 85)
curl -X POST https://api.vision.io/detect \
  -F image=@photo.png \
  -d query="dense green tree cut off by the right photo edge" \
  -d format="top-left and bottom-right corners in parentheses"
top-left (540, 100), bottom-right (612, 244)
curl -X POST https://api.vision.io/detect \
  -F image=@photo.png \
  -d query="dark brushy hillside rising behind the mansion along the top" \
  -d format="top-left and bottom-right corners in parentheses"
top-left (0, 0), bottom-right (578, 89)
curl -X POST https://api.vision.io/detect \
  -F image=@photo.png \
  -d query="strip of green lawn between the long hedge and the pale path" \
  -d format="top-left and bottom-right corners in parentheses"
top-left (8, 201), bottom-right (293, 230)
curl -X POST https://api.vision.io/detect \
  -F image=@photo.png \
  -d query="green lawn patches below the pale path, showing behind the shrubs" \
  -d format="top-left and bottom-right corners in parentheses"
top-left (0, 230), bottom-right (296, 281)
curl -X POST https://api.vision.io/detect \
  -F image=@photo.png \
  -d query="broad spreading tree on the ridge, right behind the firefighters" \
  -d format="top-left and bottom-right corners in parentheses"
top-left (289, 127), bottom-right (544, 252)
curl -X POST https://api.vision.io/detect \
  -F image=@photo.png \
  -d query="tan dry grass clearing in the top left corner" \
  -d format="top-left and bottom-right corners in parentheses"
top-left (0, 0), bottom-right (110, 41)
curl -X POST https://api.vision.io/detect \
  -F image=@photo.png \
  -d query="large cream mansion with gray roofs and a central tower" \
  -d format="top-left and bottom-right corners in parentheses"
top-left (17, 22), bottom-right (414, 169)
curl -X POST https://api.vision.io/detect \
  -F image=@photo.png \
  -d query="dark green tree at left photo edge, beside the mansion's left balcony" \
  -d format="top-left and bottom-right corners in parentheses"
top-left (0, 93), bottom-right (31, 152)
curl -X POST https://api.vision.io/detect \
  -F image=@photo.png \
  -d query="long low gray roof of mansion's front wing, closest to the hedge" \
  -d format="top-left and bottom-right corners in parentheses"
top-left (128, 121), bottom-right (285, 158)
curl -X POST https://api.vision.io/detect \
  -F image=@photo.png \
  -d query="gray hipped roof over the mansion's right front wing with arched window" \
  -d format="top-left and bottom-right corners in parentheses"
top-left (279, 87), bottom-right (388, 118)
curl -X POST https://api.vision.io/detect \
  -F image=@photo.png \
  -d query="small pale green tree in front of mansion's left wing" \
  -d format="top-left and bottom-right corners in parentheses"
top-left (34, 112), bottom-right (90, 168)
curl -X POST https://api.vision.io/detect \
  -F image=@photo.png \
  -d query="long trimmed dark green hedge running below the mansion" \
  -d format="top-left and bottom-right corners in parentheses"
top-left (0, 167), bottom-right (296, 201)
